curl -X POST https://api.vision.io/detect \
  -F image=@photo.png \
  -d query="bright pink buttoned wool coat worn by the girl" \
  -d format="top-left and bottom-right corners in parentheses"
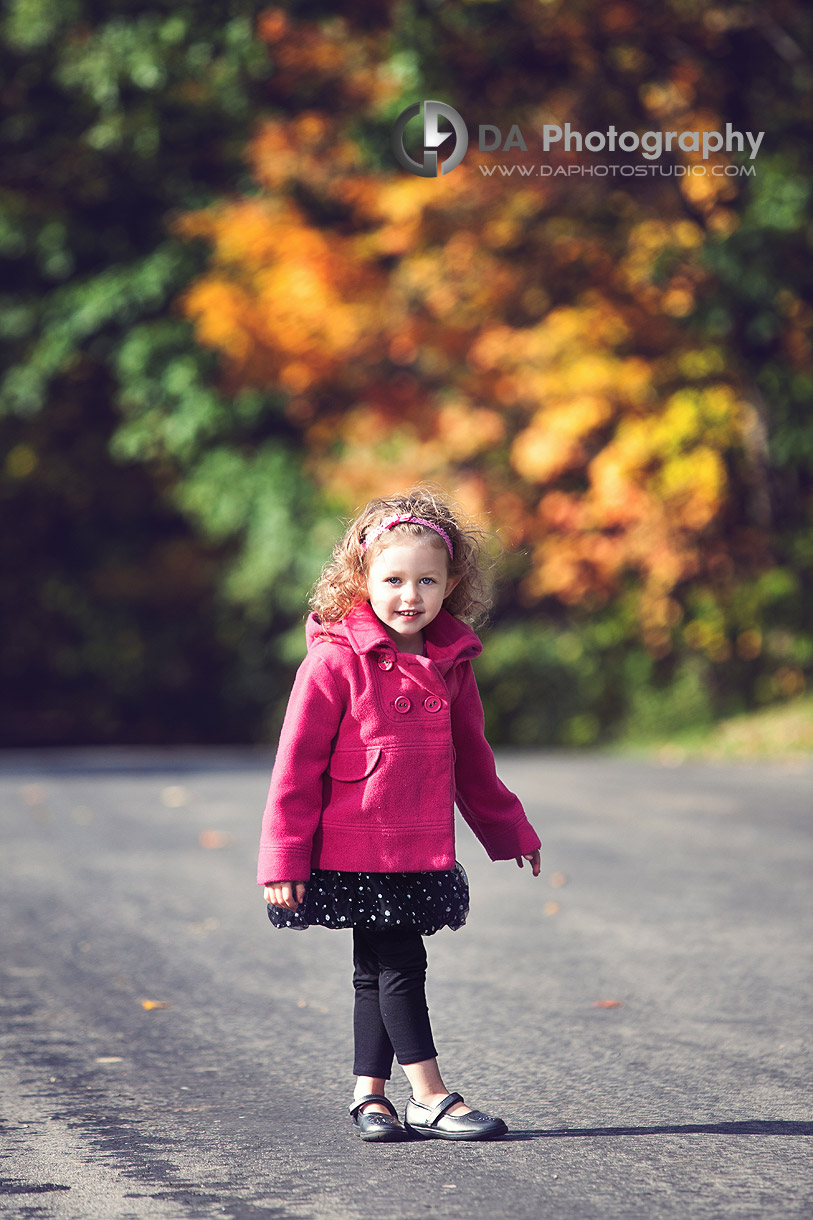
top-left (258, 601), bottom-right (540, 885)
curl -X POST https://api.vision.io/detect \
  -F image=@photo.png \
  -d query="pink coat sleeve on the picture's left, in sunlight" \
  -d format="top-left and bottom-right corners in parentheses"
top-left (256, 650), bottom-right (344, 886)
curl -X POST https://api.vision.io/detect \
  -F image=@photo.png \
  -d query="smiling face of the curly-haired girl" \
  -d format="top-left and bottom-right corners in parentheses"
top-left (367, 538), bottom-right (460, 653)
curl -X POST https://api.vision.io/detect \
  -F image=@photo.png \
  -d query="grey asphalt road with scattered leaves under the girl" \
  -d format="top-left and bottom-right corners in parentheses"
top-left (0, 752), bottom-right (813, 1220)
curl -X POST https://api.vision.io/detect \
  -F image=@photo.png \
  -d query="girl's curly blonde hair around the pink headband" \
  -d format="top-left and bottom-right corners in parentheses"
top-left (309, 484), bottom-right (493, 626)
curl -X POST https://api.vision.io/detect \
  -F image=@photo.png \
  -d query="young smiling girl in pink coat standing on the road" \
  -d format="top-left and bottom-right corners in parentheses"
top-left (258, 488), bottom-right (540, 1141)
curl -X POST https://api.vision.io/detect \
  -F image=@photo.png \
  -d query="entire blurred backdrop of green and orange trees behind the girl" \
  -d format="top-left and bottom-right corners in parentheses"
top-left (1, 0), bottom-right (813, 745)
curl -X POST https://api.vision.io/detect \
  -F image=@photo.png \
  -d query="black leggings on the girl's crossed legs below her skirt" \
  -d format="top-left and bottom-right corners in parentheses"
top-left (353, 925), bottom-right (437, 1080)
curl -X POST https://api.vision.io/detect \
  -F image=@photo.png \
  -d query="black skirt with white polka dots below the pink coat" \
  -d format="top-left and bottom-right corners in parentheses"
top-left (269, 863), bottom-right (469, 936)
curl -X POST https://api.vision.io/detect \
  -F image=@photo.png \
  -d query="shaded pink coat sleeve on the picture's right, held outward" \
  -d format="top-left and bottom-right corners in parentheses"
top-left (452, 661), bottom-right (541, 860)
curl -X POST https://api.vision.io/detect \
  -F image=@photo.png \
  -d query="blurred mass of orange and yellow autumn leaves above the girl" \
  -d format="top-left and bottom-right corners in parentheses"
top-left (174, 5), bottom-right (771, 654)
